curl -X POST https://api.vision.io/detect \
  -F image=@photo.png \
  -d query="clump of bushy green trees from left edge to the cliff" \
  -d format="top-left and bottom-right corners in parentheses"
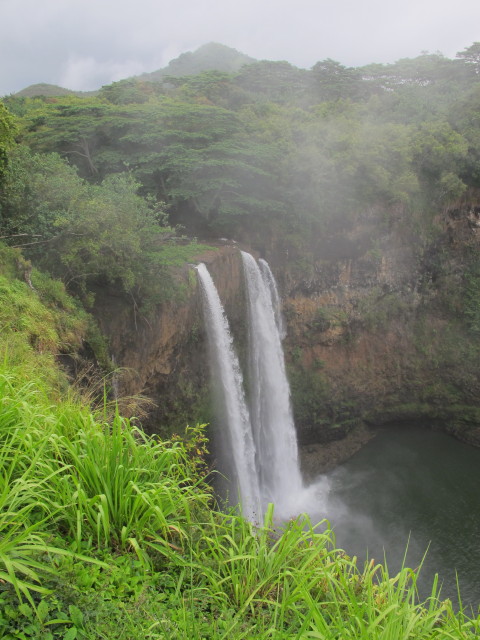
top-left (0, 145), bottom-right (184, 300)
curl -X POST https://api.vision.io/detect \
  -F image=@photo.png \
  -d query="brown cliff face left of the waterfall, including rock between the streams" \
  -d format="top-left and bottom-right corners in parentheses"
top-left (95, 246), bottom-right (243, 435)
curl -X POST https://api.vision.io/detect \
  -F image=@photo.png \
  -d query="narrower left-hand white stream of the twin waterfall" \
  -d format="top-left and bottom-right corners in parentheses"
top-left (197, 264), bottom-right (261, 521)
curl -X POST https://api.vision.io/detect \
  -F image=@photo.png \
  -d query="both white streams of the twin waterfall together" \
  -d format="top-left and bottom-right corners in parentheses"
top-left (197, 251), bottom-right (303, 522)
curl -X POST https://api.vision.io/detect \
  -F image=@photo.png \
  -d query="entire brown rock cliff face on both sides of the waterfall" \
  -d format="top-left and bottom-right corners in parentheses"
top-left (93, 208), bottom-right (480, 456)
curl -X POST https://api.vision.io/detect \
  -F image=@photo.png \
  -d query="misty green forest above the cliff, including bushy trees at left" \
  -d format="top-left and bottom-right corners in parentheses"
top-left (0, 43), bottom-right (480, 299)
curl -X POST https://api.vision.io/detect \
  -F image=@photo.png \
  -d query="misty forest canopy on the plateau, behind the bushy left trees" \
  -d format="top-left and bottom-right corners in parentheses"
top-left (6, 45), bottom-right (480, 245)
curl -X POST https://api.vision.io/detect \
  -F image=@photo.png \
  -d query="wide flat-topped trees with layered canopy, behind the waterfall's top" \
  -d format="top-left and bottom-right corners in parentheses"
top-left (20, 97), bottom-right (281, 230)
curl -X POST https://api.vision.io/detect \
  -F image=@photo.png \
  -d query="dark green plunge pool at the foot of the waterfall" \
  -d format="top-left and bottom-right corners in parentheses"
top-left (318, 428), bottom-right (480, 611)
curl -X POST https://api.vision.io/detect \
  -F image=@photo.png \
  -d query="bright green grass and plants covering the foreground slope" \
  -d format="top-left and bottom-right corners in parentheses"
top-left (0, 251), bottom-right (480, 640)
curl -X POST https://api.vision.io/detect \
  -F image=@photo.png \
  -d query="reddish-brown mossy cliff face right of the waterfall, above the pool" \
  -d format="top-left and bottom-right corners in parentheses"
top-left (278, 208), bottom-right (480, 444)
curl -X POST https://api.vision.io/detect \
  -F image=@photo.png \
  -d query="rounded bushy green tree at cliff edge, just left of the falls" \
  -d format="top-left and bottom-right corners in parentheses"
top-left (51, 173), bottom-right (173, 299)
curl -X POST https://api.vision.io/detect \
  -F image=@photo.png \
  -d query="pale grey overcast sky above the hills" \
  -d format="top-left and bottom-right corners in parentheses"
top-left (0, 0), bottom-right (480, 95)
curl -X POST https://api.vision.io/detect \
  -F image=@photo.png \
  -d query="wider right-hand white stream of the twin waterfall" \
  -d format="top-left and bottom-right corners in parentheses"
top-left (242, 251), bottom-right (303, 518)
